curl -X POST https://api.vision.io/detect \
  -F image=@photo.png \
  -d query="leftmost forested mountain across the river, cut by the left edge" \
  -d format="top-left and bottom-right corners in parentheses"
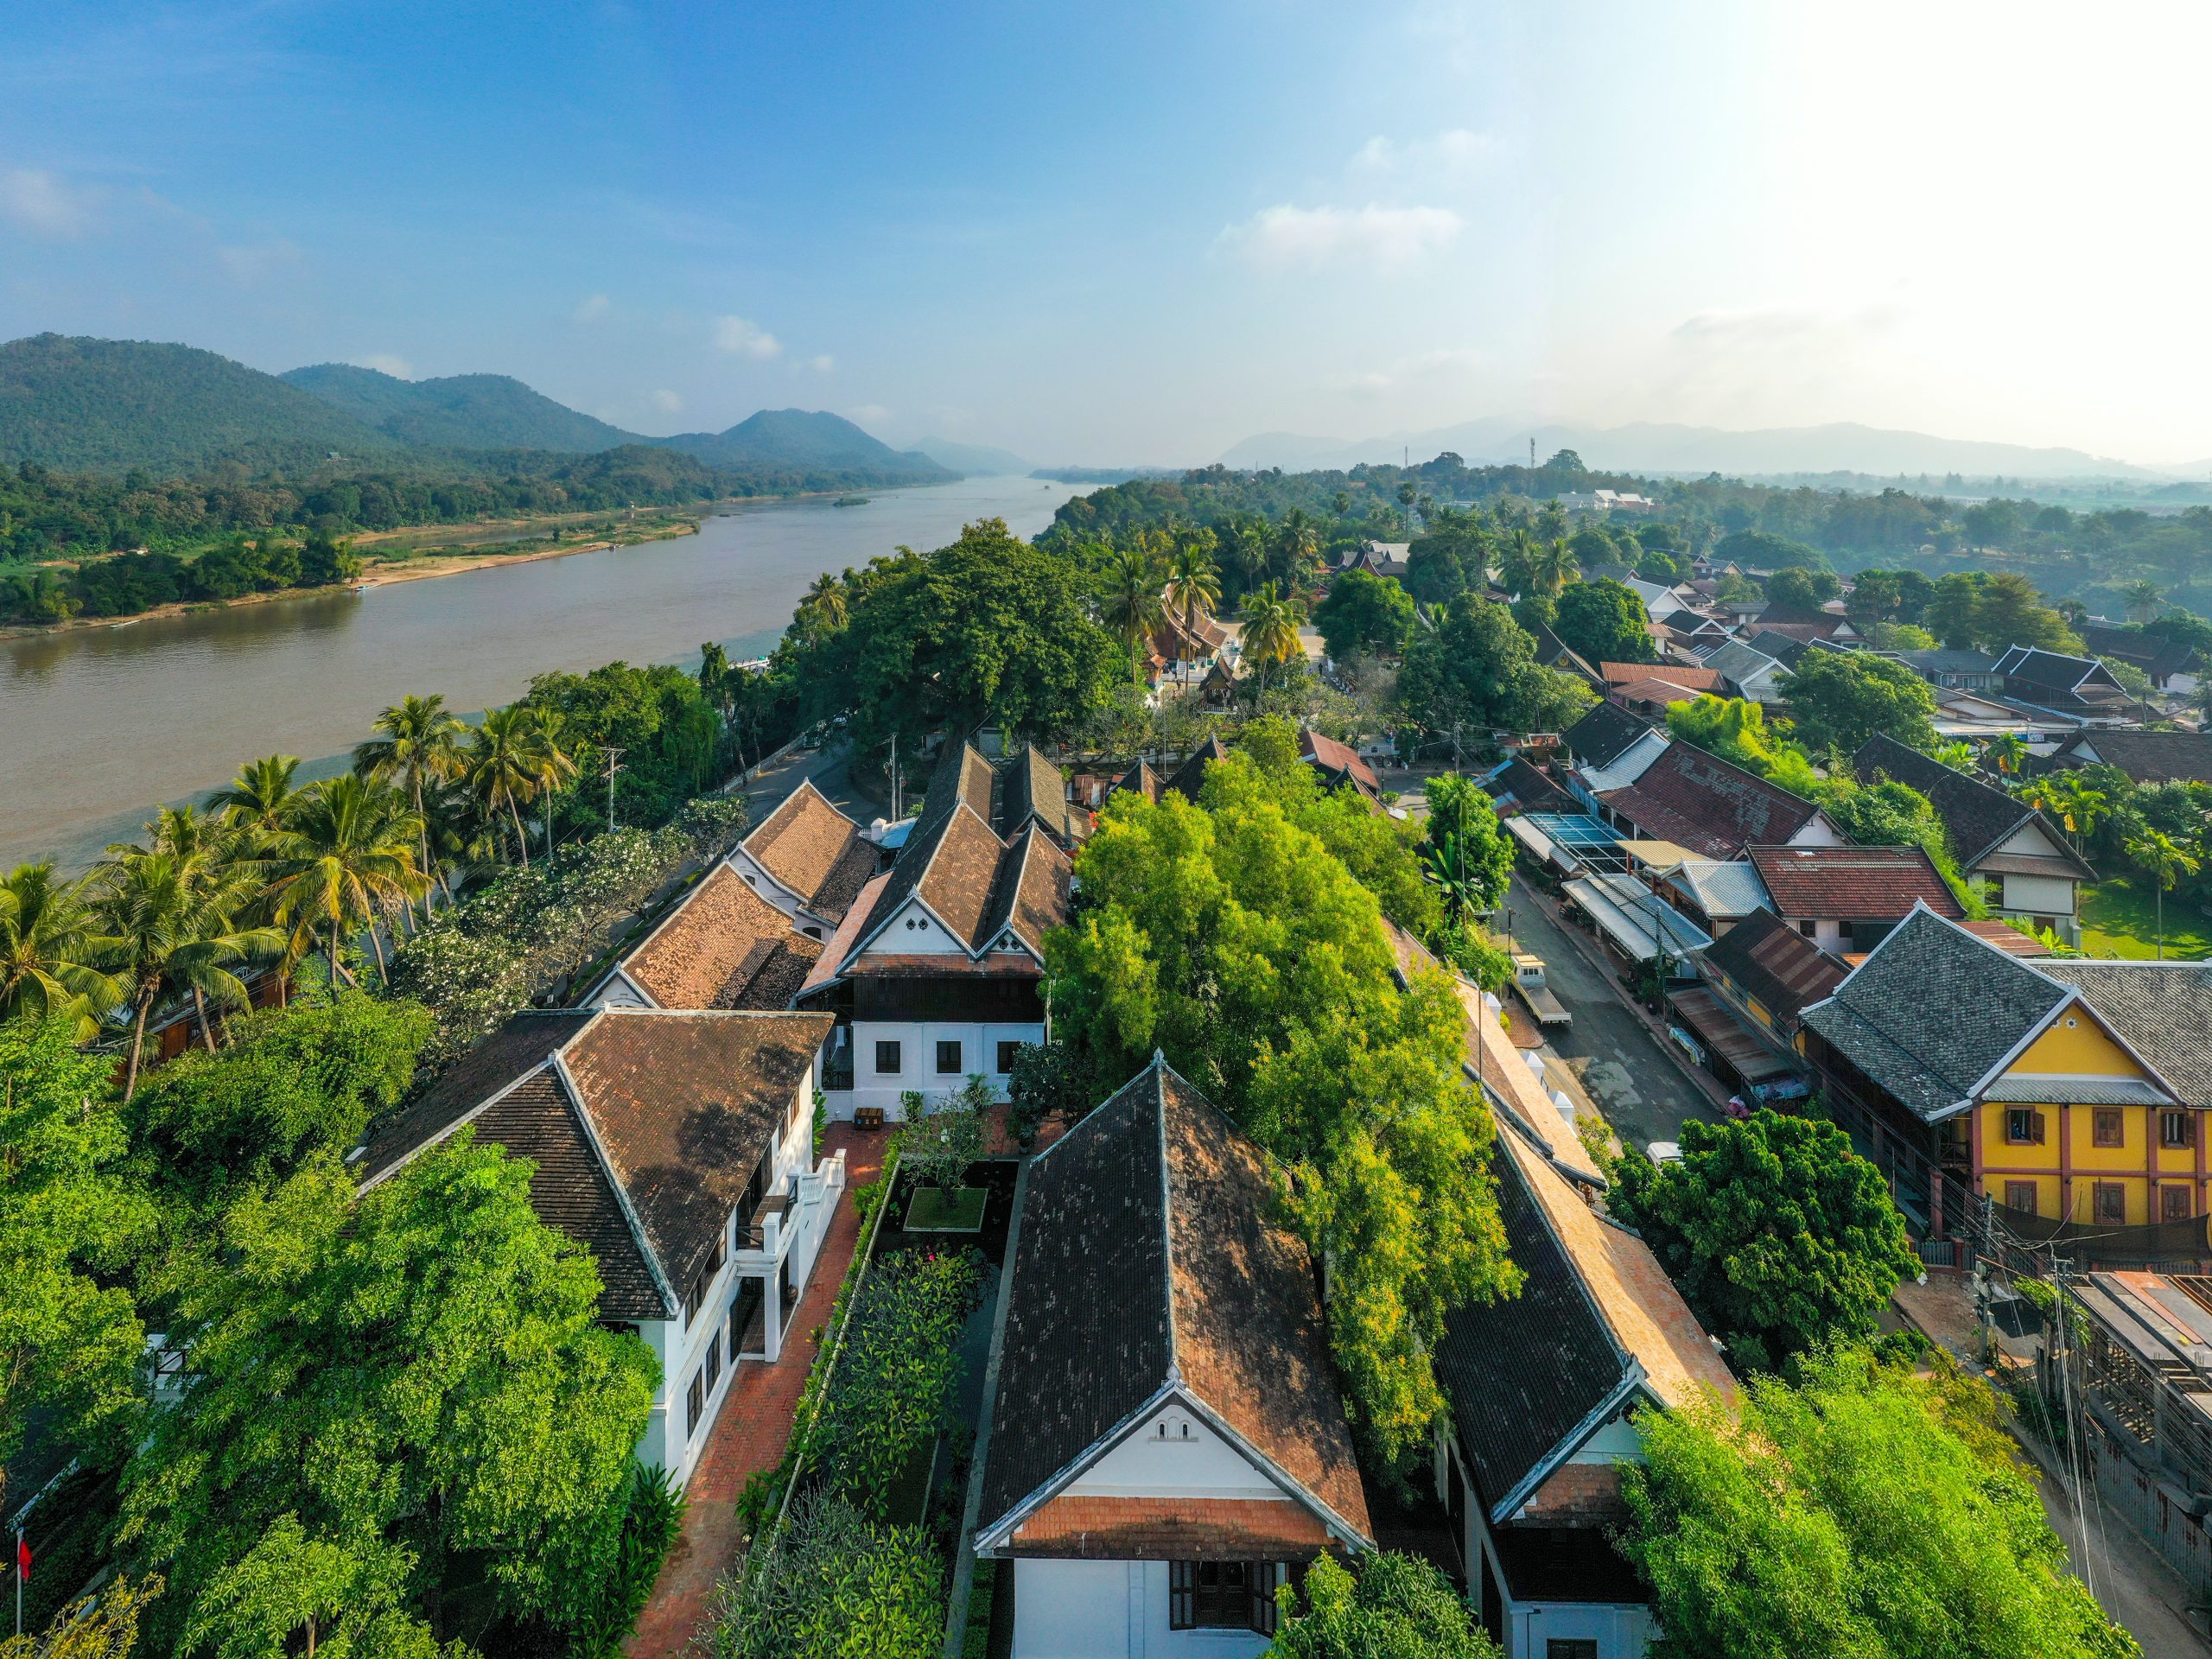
top-left (0, 334), bottom-right (400, 475)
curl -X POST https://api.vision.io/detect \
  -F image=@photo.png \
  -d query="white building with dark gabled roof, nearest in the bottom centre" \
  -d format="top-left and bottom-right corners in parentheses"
top-left (976, 1058), bottom-right (1374, 1659)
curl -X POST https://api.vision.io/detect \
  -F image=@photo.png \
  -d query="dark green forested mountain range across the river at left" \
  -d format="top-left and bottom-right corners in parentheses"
top-left (0, 334), bottom-right (960, 489)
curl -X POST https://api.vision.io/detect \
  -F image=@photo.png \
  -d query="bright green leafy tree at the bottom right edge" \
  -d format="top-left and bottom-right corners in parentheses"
top-left (1621, 1351), bottom-right (2141, 1659)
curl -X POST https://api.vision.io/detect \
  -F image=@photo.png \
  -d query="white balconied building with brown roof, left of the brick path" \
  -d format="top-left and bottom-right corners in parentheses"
top-left (354, 1008), bottom-right (845, 1486)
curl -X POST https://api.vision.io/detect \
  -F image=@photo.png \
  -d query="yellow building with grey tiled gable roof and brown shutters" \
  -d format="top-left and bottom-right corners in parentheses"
top-left (1805, 909), bottom-right (2212, 1236)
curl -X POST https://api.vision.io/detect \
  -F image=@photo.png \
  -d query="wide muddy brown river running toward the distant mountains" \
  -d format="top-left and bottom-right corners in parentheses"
top-left (0, 478), bottom-right (1075, 869)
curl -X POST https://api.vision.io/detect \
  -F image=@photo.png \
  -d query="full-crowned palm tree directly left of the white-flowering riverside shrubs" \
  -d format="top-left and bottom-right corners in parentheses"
top-left (270, 774), bottom-right (429, 984)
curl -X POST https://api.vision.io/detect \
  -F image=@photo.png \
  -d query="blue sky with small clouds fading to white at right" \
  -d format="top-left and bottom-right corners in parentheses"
top-left (0, 0), bottom-right (2212, 465)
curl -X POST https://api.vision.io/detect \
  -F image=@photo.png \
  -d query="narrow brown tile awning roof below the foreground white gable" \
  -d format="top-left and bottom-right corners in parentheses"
top-left (1013, 1496), bottom-right (1330, 1561)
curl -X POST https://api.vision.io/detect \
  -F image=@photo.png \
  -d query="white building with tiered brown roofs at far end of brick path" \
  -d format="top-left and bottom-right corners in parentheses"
top-left (798, 743), bottom-right (1077, 1122)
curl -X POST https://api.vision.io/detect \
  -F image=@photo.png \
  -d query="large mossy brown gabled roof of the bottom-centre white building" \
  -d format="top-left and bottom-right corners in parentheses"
top-left (978, 1058), bottom-right (1370, 1553)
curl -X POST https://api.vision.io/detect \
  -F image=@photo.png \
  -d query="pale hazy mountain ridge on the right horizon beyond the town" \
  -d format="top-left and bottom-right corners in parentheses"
top-left (1221, 418), bottom-right (2168, 478)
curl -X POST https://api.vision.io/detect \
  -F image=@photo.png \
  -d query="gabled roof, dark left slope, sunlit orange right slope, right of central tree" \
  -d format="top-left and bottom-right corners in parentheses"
top-left (1435, 1123), bottom-right (1737, 1522)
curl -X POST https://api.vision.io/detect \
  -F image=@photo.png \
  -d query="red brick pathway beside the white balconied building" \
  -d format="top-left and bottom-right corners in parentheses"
top-left (624, 1123), bottom-right (885, 1659)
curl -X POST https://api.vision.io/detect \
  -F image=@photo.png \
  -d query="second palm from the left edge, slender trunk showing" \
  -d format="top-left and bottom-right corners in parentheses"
top-left (95, 847), bottom-right (283, 1102)
